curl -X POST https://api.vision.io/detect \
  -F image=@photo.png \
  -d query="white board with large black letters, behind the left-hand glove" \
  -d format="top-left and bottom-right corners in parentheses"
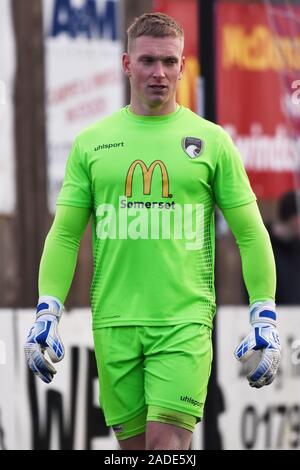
top-left (15, 309), bottom-right (118, 450)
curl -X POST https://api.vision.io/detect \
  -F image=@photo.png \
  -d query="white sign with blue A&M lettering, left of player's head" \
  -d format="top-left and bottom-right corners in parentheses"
top-left (43, 0), bottom-right (123, 212)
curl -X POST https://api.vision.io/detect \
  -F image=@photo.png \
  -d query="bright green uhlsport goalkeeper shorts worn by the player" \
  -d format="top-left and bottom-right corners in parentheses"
top-left (93, 323), bottom-right (212, 436)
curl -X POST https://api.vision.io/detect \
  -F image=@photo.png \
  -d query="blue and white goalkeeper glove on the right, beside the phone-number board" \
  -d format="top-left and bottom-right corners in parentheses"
top-left (234, 301), bottom-right (281, 388)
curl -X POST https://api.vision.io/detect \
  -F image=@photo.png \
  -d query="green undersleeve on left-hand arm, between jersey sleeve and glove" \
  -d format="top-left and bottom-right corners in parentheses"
top-left (39, 206), bottom-right (90, 304)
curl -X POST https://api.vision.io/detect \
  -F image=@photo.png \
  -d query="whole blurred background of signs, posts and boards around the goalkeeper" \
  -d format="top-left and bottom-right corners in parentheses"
top-left (0, 0), bottom-right (300, 449)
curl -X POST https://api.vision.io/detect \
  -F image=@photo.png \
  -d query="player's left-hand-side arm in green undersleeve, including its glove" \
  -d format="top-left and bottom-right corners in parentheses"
top-left (25, 206), bottom-right (90, 383)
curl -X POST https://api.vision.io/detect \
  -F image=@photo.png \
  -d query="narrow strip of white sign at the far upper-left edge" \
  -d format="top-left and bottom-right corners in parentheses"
top-left (0, 0), bottom-right (16, 214)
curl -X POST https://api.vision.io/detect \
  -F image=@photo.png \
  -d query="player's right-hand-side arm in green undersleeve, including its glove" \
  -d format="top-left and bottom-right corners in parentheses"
top-left (223, 202), bottom-right (281, 388)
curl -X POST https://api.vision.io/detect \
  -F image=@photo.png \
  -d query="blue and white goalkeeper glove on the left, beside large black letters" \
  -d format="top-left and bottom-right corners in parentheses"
top-left (24, 296), bottom-right (65, 384)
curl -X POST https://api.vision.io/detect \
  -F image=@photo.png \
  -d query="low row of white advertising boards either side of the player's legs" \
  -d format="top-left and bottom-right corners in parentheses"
top-left (0, 307), bottom-right (300, 450)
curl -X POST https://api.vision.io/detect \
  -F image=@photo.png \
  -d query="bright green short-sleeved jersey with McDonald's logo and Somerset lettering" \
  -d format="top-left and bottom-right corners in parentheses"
top-left (57, 107), bottom-right (255, 328)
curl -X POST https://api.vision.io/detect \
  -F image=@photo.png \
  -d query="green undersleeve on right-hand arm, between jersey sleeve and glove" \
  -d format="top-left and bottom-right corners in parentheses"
top-left (223, 202), bottom-right (276, 304)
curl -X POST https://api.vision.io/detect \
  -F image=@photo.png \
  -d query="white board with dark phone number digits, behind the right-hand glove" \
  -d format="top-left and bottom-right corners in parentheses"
top-left (217, 307), bottom-right (300, 450)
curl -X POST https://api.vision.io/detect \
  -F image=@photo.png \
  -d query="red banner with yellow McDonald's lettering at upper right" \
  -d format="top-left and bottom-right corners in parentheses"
top-left (216, 1), bottom-right (300, 199)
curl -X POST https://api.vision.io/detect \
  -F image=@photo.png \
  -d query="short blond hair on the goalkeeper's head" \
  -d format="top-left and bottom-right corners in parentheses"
top-left (127, 13), bottom-right (184, 51)
